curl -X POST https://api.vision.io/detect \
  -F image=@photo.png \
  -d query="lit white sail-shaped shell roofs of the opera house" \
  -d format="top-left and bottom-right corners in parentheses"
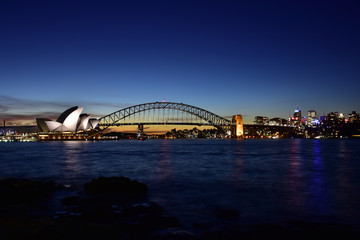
top-left (36, 106), bottom-right (99, 132)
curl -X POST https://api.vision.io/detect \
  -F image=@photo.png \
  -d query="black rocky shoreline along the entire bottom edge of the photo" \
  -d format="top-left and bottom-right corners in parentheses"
top-left (0, 177), bottom-right (360, 240)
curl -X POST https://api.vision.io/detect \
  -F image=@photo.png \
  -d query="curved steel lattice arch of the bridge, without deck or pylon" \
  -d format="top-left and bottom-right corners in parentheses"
top-left (98, 102), bottom-right (231, 131)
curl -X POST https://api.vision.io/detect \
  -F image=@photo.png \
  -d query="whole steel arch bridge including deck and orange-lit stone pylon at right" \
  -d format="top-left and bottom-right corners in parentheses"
top-left (98, 101), bottom-right (243, 137)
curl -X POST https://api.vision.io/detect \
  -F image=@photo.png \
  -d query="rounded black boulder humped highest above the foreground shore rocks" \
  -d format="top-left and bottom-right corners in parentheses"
top-left (84, 177), bottom-right (148, 194)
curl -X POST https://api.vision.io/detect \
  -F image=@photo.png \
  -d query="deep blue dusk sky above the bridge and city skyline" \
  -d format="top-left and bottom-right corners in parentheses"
top-left (0, 0), bottom-right (360, 124)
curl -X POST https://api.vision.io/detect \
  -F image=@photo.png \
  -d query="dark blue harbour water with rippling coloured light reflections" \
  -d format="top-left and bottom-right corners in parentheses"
top-left (0, 139), bottom-right (360, 231)
